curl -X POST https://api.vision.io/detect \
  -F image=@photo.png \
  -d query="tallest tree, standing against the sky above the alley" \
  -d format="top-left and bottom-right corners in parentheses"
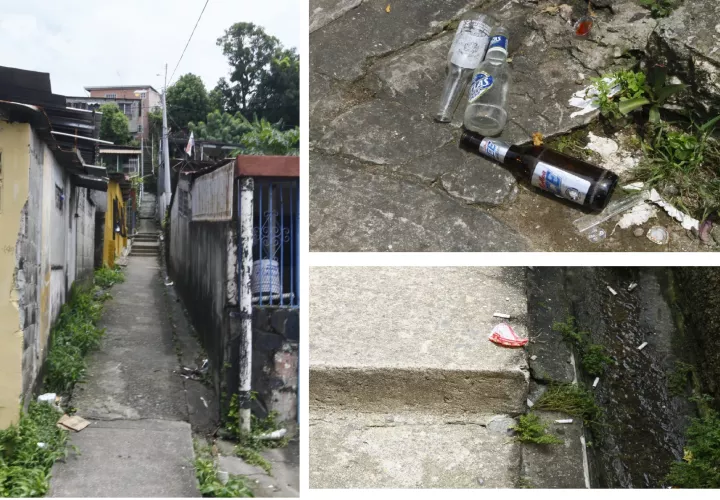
top-left (216, 23), bottom-right (281, 113)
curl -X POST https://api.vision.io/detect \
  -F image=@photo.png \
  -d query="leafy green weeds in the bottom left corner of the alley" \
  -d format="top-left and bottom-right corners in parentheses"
top-left (0, 403), bottom-right (67, 498)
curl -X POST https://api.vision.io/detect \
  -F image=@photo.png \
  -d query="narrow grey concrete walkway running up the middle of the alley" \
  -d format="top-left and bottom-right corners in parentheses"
top-left (50, 207), bottom-right (200, 497)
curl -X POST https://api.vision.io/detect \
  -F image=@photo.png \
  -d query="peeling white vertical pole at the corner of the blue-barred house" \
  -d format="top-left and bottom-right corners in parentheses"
top-left (238, 177), bottom-right (255, 433)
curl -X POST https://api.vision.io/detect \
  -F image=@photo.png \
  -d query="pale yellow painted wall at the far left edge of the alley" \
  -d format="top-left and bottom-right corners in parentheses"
top-left (0, 121), bottom-right (30, 429)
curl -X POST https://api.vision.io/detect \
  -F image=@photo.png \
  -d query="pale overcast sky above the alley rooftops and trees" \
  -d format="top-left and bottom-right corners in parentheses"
top-left (0, 0), bottom-right (301, 96)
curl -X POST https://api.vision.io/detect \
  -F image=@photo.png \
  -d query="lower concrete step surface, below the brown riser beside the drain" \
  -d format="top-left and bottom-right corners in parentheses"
top-left (310, 410), bottom-right (521, 488)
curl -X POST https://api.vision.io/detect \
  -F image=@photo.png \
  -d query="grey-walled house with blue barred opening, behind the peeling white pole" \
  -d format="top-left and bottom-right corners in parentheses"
top-left (166, 155), bottom-right (300, 428)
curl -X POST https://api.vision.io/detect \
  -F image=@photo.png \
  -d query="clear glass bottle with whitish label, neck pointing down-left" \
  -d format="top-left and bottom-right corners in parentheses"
top-left (435, 12), bottom-right (495, 122)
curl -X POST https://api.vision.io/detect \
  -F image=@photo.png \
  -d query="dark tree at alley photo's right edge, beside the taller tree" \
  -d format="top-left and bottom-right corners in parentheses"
top-left (250, 49), bottom-right (300, 128)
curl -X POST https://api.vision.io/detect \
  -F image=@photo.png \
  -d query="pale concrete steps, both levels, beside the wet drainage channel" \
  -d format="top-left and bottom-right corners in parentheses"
top-left (310, 267), bottom-right (529, 488)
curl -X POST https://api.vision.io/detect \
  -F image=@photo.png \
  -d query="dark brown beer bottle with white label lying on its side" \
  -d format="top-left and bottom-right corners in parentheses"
top-left (460, 130), bottom-right (618, 212)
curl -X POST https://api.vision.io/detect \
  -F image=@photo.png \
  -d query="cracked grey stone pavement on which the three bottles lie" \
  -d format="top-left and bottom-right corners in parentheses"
top-left (310, 0), bottom-right (716, 251)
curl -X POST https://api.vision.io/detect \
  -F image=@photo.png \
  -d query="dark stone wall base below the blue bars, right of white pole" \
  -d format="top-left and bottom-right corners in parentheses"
top-left (252, 306), bottom-right (300, 428)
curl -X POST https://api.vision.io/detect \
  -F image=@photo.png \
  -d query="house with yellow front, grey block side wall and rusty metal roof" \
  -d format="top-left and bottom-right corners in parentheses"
top-left (0, 67), bottom-right (108, 429)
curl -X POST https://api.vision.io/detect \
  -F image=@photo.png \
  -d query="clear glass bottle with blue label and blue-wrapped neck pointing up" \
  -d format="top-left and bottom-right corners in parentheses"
top-left (464, 26), bottom-right (510, 136)
